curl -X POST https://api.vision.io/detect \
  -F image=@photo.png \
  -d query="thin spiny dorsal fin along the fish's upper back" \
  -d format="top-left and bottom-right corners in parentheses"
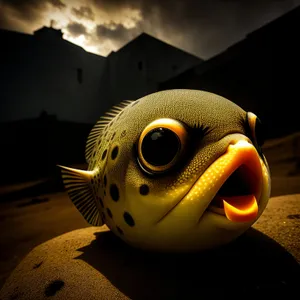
top-left (85, 100), bottom-right (134, 163)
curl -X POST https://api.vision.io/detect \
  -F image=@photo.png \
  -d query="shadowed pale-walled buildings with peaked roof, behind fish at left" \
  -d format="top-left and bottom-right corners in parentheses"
top-left (0, 27), bottom-right (202, 124)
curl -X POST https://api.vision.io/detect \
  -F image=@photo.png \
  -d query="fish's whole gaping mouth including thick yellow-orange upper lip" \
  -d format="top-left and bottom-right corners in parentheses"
top-left (178, 140), bottom-right (263, 223)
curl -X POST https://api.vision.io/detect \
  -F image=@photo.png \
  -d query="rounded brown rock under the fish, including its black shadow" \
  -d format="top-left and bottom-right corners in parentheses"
top-left (0, 195), bottom-right (300, 300)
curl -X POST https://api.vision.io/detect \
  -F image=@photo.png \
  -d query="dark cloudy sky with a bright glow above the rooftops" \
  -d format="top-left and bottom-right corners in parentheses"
top-left (0, 0), bottom-right (300, 59)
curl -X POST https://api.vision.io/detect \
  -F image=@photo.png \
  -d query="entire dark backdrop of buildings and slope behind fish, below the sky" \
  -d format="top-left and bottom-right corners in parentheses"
top-left (0, 8), bottom-right (300, 185)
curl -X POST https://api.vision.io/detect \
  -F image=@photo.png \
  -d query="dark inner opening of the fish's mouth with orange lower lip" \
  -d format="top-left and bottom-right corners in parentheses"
top-left (207, 143), bottom-right (262, 222)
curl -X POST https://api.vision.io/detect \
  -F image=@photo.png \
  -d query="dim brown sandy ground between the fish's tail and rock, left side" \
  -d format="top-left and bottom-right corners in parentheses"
top-left (0, 193), bottom-right (89, 286)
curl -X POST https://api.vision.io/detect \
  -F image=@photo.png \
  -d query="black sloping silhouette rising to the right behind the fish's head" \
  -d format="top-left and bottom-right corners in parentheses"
top-left (160, 7), bottom-right (300, 137)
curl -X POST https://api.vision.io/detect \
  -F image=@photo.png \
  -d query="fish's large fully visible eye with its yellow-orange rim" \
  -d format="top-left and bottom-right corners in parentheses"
top-left (137, 118), bottom-right (188, 173)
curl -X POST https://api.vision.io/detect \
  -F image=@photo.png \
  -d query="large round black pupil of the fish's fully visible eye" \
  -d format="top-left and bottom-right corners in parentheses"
top-left (142, 127), bottom-right (180, 166)
